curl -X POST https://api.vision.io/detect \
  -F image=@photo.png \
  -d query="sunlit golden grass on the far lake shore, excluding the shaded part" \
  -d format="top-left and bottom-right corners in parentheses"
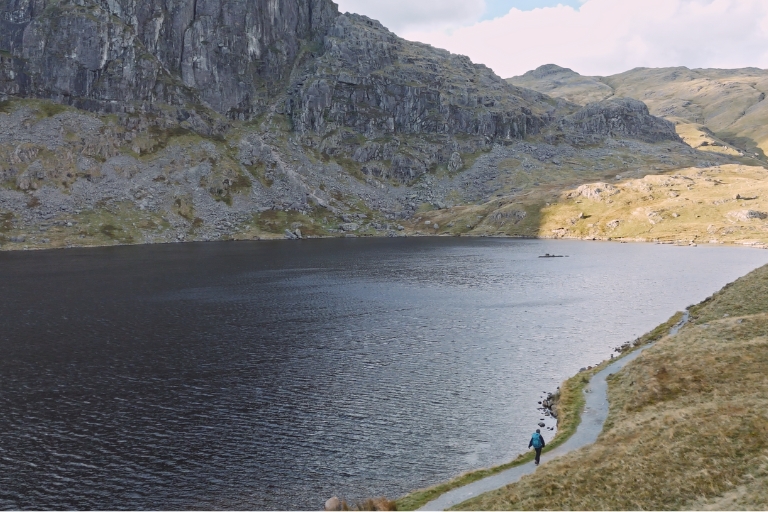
top-left (539, 164), bottom-right (768, 245)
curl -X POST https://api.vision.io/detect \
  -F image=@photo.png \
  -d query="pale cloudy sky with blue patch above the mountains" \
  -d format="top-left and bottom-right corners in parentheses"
top-left (335, 0), bottom-right (768, 78)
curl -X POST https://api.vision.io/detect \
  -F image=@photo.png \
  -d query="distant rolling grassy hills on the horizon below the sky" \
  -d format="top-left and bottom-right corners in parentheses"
top-left (508, 65), bottom-right (768, 162)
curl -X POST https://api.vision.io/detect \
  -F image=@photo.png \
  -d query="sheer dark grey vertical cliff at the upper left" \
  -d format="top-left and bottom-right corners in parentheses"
top-left (0, 0), bottom-right (337, 117)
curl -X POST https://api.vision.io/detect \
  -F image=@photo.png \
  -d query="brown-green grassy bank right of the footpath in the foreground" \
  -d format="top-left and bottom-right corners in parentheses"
top-left (456, 267), bottom-right (768, 510)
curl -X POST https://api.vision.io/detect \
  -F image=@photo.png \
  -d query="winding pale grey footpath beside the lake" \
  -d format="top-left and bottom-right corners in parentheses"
top-left (418, 311), bottom-right (688, 510)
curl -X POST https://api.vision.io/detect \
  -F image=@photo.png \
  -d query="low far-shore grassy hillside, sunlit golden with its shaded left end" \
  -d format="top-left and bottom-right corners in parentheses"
top-left (409, 164), bottom-right (768, 246)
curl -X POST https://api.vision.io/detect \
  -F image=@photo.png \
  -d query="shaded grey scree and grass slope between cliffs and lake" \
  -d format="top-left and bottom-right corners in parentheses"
top-left (0, 95), bottom-right (751, 250)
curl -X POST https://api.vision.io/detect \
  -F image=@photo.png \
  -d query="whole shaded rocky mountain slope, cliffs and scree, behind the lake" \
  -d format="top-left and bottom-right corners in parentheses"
top-left (0, 0), bottom-right (732, 249)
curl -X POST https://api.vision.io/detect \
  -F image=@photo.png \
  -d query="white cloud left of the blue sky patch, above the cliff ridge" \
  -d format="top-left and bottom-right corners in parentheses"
top-left (336, 0), bottom-right (485, 34)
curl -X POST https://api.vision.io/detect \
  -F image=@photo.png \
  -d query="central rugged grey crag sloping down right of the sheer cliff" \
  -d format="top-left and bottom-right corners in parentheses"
top-left (281, 14), bottom-right (567, 183)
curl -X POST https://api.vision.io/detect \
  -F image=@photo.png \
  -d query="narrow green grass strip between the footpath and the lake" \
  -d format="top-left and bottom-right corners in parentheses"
top-left (396, 313), bottom-right (682, 510)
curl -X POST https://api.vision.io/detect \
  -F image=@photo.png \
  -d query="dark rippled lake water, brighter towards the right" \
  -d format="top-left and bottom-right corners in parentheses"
top-left (0, 238), bottom-right (768, 509)
